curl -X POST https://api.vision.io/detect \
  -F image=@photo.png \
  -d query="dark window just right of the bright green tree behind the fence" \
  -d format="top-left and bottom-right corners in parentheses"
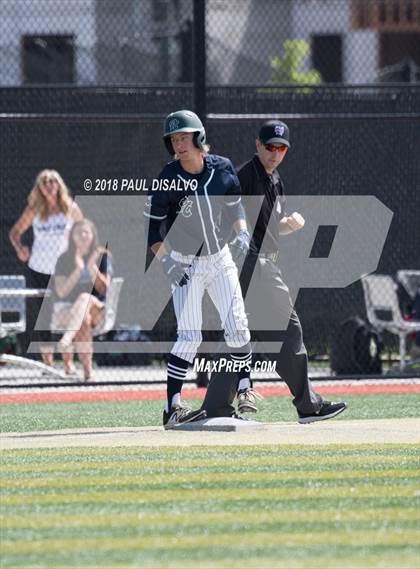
top-left (312, 35), bottom-right (343, 83)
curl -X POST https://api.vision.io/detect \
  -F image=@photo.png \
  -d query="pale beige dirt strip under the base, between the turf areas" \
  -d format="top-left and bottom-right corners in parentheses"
top-left (0, 418), bottom-right (420, 450)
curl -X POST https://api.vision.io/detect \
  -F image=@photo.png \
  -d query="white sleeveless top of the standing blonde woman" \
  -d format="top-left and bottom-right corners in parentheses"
top-left (28, 212), bottom-right (74, 275)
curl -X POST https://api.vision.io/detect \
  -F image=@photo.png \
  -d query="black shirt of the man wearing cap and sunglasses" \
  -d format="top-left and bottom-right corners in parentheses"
top-left (238, 154), bottom-right (286, 253)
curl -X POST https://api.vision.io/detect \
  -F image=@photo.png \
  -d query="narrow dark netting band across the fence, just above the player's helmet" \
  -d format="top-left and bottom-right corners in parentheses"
top-left (0, 84), bottom-right (420, 115)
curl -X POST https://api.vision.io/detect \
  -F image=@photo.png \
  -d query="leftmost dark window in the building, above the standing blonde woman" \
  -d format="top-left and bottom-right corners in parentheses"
top-left (22, 35), bottom-right (75, 83)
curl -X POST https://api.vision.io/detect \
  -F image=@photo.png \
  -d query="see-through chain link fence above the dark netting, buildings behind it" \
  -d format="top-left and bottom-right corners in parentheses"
top-left (0, 0), bottom-right (420, 86)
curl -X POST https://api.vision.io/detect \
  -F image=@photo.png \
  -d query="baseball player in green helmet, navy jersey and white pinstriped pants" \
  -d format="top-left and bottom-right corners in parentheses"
top-left (144, 110), bottom-right (258, 429)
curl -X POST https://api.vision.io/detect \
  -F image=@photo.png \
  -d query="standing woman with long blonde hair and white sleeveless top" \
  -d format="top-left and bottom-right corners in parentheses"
top-left (9, 170), bottom-right (83, 375)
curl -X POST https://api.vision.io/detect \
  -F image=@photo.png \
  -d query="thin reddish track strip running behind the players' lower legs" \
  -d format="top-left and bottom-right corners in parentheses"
top-left (0, 383), bottom-right (420, 405)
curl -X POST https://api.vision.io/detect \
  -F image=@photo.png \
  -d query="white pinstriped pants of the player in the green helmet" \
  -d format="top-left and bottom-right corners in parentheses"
top-left (171, 245), bottom-right (251, 363)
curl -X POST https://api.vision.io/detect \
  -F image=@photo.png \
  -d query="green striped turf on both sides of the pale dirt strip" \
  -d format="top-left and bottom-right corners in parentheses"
top-left (0, 395), bottom-right (420, 569)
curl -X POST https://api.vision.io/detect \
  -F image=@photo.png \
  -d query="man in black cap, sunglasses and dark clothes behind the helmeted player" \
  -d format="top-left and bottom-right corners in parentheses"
top-left (203, 120), bottom-right (346, 423)
